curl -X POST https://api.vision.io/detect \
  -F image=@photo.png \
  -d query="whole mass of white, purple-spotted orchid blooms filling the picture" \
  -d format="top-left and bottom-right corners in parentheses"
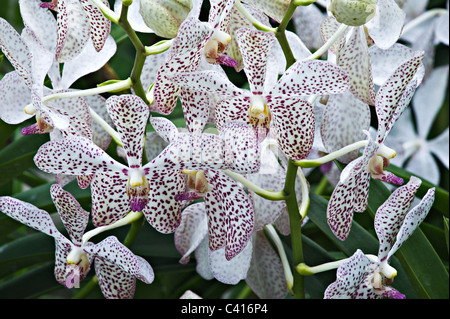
top-left (0, 0), bottom-right (448, 298)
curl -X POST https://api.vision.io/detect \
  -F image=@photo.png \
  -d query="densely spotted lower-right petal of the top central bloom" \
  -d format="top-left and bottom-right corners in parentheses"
top-left (269, 97), bottom-right (315, 160)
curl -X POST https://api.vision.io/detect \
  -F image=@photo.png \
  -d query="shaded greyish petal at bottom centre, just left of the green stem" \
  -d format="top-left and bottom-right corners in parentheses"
top-left (245, 232), bottom-right (288, 299)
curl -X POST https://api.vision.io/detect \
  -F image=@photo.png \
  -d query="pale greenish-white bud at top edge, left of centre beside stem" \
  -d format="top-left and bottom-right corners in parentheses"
top-left (139, 0), bottom-right (192, 38)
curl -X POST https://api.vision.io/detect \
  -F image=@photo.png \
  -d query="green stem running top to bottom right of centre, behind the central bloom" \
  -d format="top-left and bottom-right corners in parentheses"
top-left (275, 1), bottom-right (305, 299)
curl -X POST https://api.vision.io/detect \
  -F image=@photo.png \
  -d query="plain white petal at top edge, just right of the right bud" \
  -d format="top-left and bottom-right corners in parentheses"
top-left (366, 0), bottom-right (406, 50)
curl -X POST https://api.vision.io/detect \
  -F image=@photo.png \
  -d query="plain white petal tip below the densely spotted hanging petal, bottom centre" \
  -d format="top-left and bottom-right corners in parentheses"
top-left (209, 241), bottom-right (252, 285)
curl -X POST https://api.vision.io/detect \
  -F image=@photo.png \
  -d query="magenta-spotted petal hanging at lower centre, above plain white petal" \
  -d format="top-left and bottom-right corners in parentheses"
top-left (205, 171), bottom-right (254, 260)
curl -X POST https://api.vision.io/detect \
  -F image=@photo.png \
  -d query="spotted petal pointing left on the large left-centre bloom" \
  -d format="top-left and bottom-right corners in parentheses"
top-left (34, 137), bottom-right (127, 175)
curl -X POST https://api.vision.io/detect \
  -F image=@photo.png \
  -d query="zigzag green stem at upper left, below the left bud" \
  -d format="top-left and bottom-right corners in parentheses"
top-left (119, 6), bottom-right (150, 104)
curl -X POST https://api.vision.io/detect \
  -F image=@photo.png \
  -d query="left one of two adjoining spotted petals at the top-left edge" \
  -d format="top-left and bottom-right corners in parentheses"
top-left (56, 0), bottom-right (90, 63)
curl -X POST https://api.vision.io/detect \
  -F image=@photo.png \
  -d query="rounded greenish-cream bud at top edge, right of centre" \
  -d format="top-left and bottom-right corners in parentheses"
top-left (330, 0), bottom-right (376, 27)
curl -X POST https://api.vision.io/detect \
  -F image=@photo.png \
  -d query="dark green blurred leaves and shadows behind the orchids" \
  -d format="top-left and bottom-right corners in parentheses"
top-left (0, 0), bottom-right (449, 299)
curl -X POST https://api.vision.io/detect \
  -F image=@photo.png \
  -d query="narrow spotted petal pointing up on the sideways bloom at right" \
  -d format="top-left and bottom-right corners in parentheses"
top-left (375, 52), bottom-right (423, 143)
